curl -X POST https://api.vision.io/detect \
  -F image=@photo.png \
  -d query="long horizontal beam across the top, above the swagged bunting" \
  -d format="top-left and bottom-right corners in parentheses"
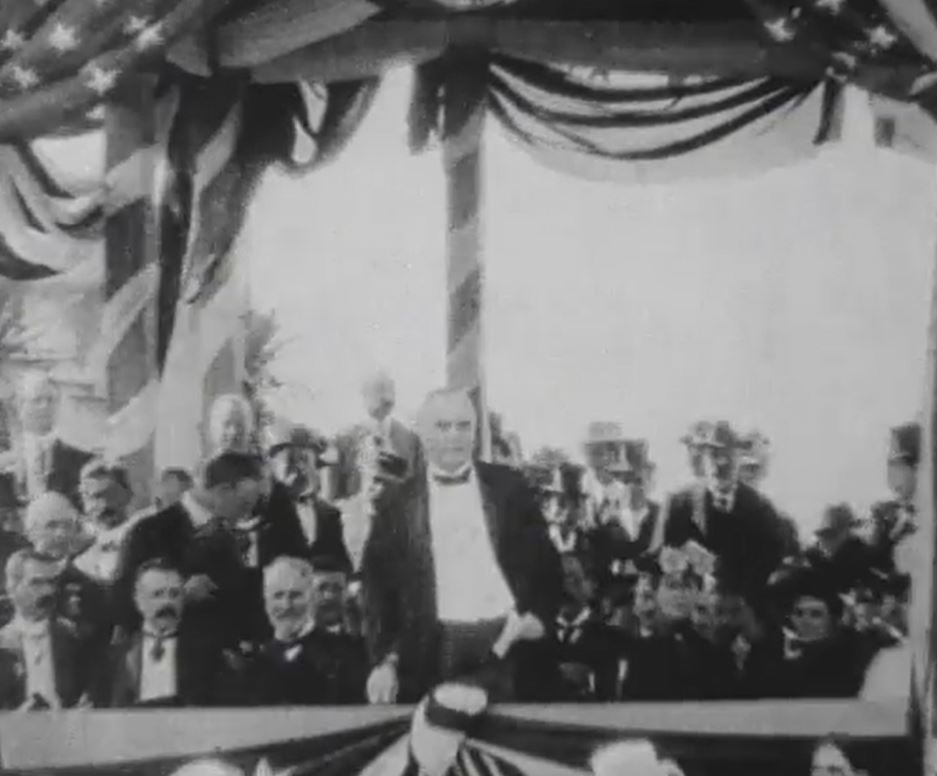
top-left (247, 16), bottom-right (826, 82)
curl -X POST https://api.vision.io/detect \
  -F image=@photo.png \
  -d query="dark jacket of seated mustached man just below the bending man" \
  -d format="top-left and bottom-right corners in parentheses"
top-left (93, 627), bottom-right (229, 708)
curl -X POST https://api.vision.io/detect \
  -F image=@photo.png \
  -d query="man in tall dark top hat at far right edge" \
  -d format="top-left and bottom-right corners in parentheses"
top-left (870, 423), bottom-right (921, 573)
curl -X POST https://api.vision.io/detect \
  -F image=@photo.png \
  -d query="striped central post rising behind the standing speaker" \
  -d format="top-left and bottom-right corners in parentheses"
top-left (442, 50), bottom-right (491, 460)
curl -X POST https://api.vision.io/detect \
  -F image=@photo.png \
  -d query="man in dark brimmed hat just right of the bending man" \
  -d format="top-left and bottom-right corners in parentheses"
top-left (267, 423), bottom-right (351, 571)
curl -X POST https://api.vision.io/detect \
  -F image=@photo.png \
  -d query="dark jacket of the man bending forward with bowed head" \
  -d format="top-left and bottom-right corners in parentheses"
top-left (114, 504), bottom-right (250, 643)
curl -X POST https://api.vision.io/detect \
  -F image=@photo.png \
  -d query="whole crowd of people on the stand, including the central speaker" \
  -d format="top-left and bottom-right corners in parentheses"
top-left (0, 375), bottom-right (921, 710)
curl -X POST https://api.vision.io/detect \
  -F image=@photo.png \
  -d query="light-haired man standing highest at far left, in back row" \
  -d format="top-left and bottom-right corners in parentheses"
top-left (0, 373), bottom-right (92, 506)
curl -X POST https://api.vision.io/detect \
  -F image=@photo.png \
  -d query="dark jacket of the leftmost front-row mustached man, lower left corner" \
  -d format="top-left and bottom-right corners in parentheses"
top-left (0, 619), bottom-right (92, 709)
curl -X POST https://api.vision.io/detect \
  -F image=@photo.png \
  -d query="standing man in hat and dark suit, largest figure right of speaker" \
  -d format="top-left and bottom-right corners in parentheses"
top-left (662, 421), bottom-right (786, 597)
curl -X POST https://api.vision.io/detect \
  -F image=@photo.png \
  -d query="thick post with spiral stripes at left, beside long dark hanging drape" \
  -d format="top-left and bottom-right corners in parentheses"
top-left (101, 76), bottom-right (158, 503)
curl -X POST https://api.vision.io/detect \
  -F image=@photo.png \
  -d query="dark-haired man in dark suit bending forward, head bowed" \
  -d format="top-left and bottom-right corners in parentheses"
top-left (114, 452), bottom-right (264, 643)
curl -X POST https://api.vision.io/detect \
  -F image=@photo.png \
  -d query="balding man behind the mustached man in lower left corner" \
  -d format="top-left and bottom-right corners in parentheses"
top-left (25, 491), bottom-right (113, 645)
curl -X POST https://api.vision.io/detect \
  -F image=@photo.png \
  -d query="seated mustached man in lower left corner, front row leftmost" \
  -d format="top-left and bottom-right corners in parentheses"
top-left (0, 549), bottom-right (89, 711)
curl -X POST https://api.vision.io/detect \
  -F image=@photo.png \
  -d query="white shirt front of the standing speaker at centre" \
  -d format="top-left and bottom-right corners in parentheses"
top-left (429, 471), bottom-right (515, 622)
